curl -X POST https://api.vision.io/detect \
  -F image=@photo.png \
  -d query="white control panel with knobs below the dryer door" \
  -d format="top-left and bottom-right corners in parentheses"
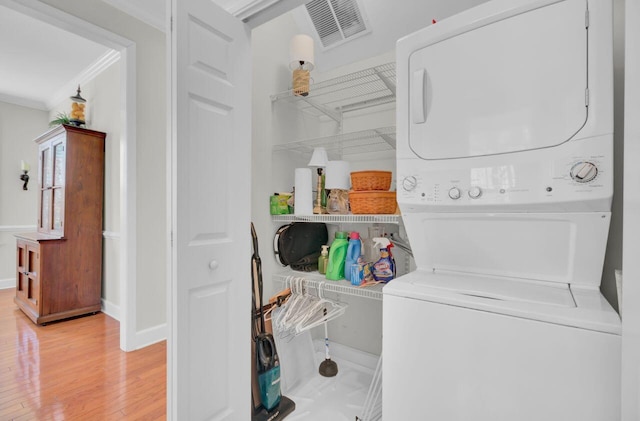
top-left (398, 144), bottom-right (613, 210)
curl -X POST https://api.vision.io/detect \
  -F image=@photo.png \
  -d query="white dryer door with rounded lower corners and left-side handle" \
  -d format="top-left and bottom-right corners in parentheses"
top-left (410, 0), bottom-right (588, 159)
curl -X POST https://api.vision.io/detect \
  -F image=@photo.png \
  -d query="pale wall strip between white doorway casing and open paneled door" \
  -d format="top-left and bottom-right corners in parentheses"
top-left (41, 0), bottom-right (167, 343)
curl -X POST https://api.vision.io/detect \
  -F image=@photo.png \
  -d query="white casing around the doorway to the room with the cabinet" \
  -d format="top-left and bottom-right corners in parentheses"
top-left (0, 0), bottom-right (137, 351)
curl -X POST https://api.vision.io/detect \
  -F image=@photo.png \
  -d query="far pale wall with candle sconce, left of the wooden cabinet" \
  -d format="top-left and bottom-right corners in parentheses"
top-left (0, 102), bottom-right (49, 288)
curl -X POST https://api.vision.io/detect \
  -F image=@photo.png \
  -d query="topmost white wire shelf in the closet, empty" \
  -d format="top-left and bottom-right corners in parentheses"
top-left (271, 62), bottom-right (396, 120)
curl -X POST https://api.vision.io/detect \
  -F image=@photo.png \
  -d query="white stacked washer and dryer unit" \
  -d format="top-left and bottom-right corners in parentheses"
top-left (383, 0), bottom-right (621, 421)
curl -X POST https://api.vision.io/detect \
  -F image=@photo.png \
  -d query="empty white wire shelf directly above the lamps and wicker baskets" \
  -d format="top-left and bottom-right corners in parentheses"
top-left (273, 126), bottom-right (396, 159)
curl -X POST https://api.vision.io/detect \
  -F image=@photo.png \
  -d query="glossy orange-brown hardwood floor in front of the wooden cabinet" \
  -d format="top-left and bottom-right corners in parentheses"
top-left (0, 289), bottom-right (166, 421)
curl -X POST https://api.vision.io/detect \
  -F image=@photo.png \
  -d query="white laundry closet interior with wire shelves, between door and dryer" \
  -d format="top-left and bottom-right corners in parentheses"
top-left (252, 2), bottom-right (430, 420)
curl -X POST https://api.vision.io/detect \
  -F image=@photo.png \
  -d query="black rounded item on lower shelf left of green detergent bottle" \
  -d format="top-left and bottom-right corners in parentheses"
top-left (273, 222), bottom-right (329, 272)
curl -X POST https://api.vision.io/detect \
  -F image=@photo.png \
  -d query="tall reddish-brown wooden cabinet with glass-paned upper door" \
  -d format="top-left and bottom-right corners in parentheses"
top-left (14, 125), bottom-right (106, 324)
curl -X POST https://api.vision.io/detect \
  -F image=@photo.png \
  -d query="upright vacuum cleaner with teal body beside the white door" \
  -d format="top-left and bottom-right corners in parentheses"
top-left (251, 223), bottom-right (295, 421)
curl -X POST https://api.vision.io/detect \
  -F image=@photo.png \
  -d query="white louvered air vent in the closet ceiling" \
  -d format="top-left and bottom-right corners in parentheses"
top-left (305, 0), bottom-right (369, 48)
